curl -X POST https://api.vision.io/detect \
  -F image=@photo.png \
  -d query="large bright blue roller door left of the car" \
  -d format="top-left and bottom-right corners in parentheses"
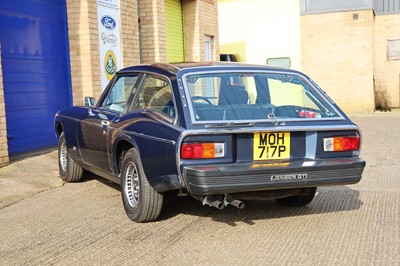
top-left (0, 0), bottom-right (71, 155)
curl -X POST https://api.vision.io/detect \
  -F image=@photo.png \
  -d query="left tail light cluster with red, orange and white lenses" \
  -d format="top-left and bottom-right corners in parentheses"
top-left (181, 143), bottom-right (225, 159)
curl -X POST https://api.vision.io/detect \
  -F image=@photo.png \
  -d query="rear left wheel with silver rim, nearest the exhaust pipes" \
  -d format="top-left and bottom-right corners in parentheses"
top-left (121, 148), bottom-right (163, 223)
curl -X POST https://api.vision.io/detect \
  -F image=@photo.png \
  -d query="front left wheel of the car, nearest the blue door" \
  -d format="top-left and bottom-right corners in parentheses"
top-left (58, 132), bottom-right (83, 182)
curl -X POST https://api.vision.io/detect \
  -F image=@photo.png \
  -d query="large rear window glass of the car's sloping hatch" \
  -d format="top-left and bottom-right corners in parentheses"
top-left (184, 72), bottom-right (339, 122)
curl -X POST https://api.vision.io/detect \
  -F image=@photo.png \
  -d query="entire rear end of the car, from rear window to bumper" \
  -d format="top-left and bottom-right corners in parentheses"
top-left (178, 67), bottom-right (365, 194)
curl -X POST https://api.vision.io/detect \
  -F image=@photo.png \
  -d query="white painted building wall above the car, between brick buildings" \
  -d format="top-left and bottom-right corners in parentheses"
top-left (218, 0), bottom-right (301, 70)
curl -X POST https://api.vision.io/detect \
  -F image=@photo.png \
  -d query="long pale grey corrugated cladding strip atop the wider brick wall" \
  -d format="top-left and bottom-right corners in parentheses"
top-left (300, 0), bottom-right (373, 15)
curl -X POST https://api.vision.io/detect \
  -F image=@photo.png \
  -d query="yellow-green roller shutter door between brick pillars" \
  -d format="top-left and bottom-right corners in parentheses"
top-left (164, 0), bottom-right (185, 63)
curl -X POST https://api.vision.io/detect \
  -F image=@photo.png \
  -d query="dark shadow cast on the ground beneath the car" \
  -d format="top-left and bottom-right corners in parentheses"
top-left (82, 172), bottom-right (363, 226)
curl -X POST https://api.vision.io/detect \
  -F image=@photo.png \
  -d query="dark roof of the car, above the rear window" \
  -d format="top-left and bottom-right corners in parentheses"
top-left (118, 62), bottom-right (298, 76)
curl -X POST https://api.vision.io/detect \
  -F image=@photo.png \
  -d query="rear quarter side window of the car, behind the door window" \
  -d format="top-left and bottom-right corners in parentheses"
top-left (133, 76), bottom-right (175, 117)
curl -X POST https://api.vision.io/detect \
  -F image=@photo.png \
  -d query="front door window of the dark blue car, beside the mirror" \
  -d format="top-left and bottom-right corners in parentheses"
top-left (101, 75), bottom-right (138, 112)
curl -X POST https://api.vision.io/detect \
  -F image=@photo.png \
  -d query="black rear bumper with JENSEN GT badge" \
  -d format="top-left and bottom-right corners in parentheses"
top-left (183, 158), bottom-right (365, 195)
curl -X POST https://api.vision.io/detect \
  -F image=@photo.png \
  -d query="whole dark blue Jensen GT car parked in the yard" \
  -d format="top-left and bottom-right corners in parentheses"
top-left (55, 63), bottom-right (365, 222)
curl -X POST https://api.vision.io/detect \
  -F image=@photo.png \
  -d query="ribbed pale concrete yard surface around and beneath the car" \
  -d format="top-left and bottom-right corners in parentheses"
top-left (0, 112), bottom-right (400, 266)
